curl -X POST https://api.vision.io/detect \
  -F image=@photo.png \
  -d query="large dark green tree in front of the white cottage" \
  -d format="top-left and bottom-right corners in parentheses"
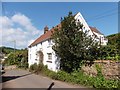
top-left (52, 12), bottom-right (98, 72)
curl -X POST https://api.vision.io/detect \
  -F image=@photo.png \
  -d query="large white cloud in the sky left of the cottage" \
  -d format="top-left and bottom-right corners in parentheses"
top-left (0, 13), bottom-right (43, 48)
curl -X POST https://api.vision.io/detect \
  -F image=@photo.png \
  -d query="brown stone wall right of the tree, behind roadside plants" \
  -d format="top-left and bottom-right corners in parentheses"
top-left (82, 60), bottom-right (120, 79)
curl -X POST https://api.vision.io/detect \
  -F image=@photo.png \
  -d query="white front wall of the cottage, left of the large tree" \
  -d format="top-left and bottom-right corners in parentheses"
top-left (28, 40), bottom-right (60, 71)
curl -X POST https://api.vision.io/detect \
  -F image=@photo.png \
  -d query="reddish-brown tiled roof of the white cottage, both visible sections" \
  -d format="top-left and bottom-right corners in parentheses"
top-left (29, 24), bottom-right (101, 47)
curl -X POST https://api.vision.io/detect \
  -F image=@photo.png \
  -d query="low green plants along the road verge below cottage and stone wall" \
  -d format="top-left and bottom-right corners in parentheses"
top-left (30, 64), bottom-right (120, 88)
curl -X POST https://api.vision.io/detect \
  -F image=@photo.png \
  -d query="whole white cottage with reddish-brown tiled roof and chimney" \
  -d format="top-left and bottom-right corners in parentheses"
top-left (28, 12), bottom-right (108, 71)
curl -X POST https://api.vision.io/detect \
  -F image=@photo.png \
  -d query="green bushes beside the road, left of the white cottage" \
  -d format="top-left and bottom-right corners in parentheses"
top-left (5, 49), bottom-right (28, 69)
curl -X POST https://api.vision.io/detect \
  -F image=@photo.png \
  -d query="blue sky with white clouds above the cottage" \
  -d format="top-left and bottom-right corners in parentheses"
top-left (0, 2), bottom-right (118, 49)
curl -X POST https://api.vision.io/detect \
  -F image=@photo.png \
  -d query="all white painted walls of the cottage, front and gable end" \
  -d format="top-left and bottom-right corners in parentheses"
top-left (28, 13), bottom-right (107, 71)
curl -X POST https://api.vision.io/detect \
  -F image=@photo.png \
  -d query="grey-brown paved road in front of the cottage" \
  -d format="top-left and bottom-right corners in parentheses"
top-left (2, 69), bottom-right (85, 88)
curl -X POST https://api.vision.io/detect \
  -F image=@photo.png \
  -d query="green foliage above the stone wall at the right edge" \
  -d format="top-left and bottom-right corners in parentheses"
top-left (99, 33), bottom-right (120, 60)
